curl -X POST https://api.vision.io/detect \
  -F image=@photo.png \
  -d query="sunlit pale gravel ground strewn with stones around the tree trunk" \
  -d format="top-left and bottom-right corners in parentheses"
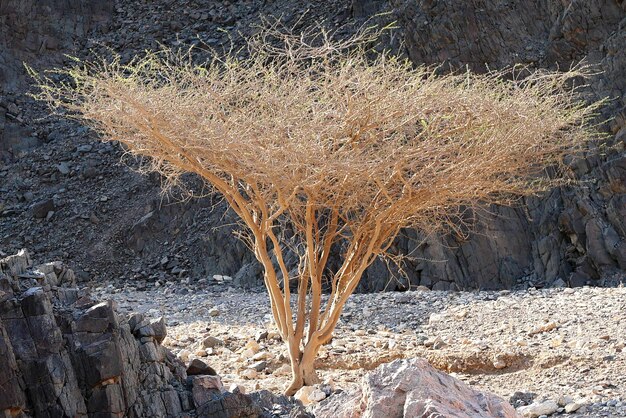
top-left (92, 280), bottom-right (626, 417)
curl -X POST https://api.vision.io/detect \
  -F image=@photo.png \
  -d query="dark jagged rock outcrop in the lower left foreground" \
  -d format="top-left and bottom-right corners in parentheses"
top-left (0, 251), bottom-right (294, 418)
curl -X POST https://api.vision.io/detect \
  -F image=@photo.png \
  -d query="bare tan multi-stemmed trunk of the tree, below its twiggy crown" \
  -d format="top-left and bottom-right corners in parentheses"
top-left (210, 180), bottom-right (395, 395)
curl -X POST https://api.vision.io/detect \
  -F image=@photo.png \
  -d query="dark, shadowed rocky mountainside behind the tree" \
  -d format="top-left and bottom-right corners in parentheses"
top-left (0, 0), bottom-right (626, 291)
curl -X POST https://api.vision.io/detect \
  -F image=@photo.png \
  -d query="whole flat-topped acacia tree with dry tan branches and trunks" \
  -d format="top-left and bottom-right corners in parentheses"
top-left (31, 29), bottom-right (598, 394)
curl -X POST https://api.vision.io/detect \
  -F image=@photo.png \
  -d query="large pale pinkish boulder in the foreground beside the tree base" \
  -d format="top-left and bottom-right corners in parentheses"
top-left (315, 359), bottom-right (518, 418)
